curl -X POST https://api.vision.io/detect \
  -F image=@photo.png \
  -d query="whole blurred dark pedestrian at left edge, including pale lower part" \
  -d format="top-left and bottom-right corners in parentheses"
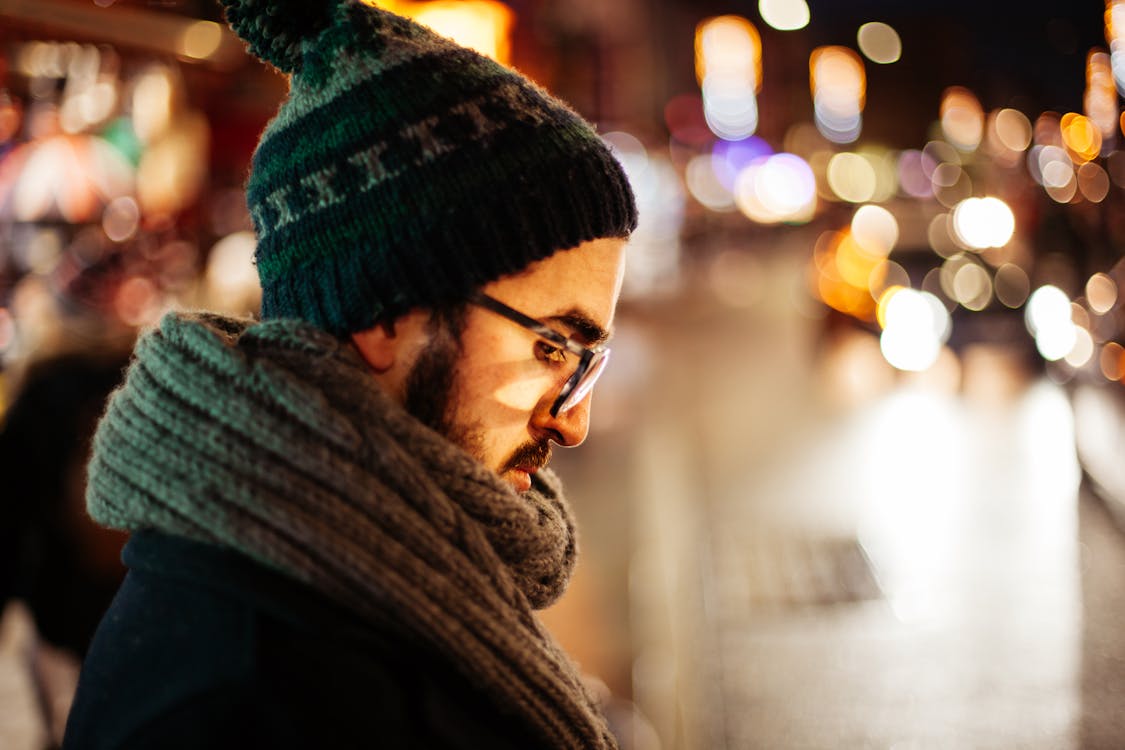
top-left (0, 347), bottom-right (127, 750)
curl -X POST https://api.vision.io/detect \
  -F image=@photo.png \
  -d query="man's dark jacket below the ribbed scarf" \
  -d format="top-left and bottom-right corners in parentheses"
top-left (63, 532), bottom-right (538, 750)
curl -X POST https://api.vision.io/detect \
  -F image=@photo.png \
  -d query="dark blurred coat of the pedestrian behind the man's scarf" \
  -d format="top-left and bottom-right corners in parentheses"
top-left (0, 351), bottom-right (126, 659)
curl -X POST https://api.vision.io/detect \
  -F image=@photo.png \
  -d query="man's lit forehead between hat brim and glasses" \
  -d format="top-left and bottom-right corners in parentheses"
top-left (484, 238), bottom-right (626, 329)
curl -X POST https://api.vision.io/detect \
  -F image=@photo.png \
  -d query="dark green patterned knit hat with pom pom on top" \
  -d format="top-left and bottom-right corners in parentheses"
top-left (223, 0), bottom-right (637, 335)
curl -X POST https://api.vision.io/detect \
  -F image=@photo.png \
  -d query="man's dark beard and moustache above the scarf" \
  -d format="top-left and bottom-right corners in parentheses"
top-left (404, 323), bottom-right (551, 475)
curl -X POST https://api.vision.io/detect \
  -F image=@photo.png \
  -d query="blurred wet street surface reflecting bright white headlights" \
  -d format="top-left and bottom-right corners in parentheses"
top-left (556, 241), bottom-right (1125, 749)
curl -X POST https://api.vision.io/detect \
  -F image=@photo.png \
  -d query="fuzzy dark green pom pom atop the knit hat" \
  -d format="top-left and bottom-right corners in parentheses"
top-left (223, 0), bottom-right (335, 73)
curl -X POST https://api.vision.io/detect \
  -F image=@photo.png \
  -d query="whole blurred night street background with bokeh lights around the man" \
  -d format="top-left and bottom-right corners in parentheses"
top-left (0, 0), bottom-right (1125, 750)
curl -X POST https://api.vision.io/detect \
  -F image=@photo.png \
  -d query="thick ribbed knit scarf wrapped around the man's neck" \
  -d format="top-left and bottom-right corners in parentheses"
top-left (87, 315), bottom-right (615, 748)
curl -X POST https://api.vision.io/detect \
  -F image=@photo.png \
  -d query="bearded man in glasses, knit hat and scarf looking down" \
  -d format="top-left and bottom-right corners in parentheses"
top-left (64, 0), bottom-right (636, 748)
